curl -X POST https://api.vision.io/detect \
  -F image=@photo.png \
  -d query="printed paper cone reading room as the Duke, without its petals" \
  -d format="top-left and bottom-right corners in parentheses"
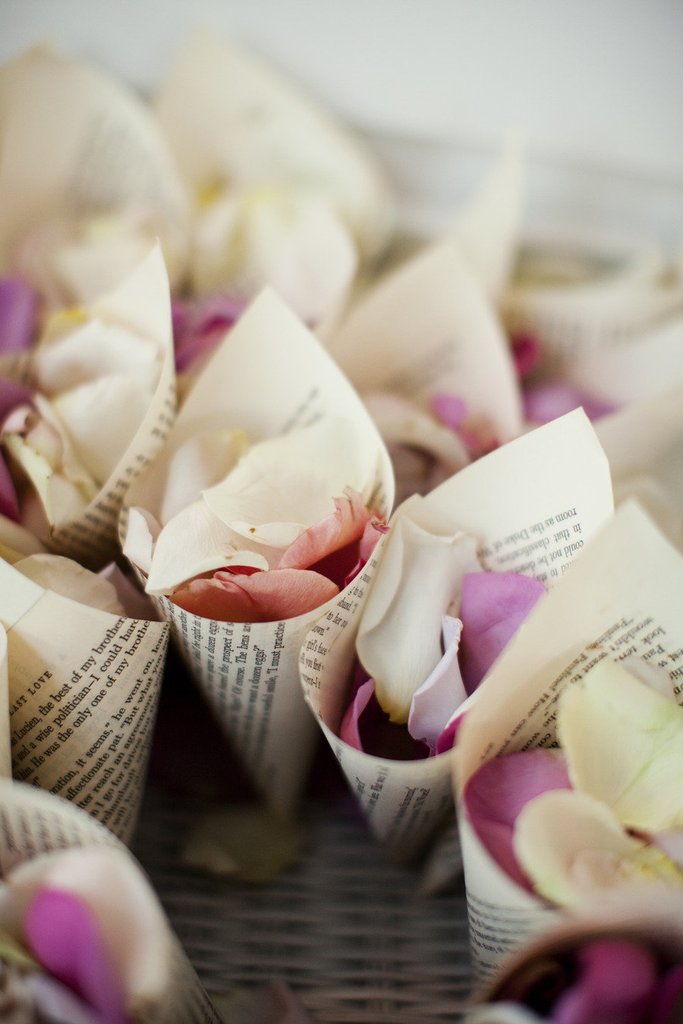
top-left (300, 411), bottom-right (612, 860)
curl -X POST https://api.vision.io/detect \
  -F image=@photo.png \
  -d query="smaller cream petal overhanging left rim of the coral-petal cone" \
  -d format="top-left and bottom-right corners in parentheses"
top-left (145, 501), bottom-right (269, 594)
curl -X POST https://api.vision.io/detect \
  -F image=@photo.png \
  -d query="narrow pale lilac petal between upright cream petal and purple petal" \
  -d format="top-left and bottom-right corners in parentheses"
top-left (408, 615), bottom-right (467, 750)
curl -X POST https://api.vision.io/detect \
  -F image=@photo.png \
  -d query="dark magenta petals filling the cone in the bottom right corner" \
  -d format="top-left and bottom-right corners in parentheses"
top-left (472, 935), bottom-right (683, 1024)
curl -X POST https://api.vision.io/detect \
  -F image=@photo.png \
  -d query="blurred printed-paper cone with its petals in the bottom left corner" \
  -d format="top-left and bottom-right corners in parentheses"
top-left (0, 780), bottom-right (219, 1024)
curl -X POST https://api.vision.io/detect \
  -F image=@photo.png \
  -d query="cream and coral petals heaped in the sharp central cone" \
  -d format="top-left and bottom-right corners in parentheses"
top-left (124, 418), bottom-right (386, 623)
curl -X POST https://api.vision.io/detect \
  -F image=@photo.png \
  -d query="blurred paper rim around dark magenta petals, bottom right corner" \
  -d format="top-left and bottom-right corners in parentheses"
top-left (473, 889), bottom-right (683, 1024)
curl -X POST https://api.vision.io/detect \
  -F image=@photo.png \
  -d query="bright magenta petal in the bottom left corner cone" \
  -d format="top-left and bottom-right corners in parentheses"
top-left (24, 889), bottom-right (126, 1024)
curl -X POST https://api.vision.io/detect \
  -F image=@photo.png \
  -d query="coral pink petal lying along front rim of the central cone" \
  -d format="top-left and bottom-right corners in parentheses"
top-left (171, 568), bottom-right (339, 623)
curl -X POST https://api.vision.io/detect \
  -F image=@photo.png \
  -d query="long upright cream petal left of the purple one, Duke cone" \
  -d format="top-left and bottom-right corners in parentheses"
top-left (356, 498), bottom-right (478, 722)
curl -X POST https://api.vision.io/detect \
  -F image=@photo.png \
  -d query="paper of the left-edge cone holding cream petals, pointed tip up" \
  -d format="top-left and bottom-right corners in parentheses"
top-left (0, 245), bottom-right (175, 569)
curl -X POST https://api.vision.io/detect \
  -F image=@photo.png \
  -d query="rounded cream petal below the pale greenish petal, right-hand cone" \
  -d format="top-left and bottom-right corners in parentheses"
top-left (514, 790), bottom-right (683, 905)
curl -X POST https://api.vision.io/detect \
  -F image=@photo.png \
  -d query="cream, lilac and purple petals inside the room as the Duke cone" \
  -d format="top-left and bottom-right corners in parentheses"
top-left (340, 499), bottom-right (545, 760)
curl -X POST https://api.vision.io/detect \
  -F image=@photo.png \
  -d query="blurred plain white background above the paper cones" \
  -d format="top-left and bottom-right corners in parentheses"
top-left (0, 0), bottom-right (683, 246)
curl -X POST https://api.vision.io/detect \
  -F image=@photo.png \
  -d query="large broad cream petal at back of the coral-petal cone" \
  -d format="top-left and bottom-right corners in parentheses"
top-left (203, 417), bottom-right (376, 548)
